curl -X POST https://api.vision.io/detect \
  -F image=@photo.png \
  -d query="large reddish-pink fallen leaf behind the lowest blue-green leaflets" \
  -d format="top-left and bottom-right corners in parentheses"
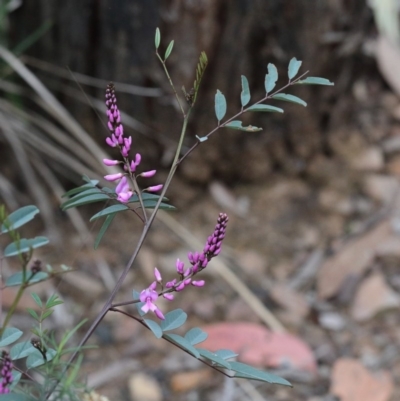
top-left (201, 322), bottom-right (316, 373)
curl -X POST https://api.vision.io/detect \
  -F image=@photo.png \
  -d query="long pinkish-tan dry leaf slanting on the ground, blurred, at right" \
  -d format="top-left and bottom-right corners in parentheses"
top-left (317, 221), bottom-right (394, 298)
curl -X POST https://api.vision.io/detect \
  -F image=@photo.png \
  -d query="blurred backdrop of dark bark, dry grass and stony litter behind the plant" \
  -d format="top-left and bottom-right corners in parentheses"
top-left (0, 0), bottom-right (400, 401)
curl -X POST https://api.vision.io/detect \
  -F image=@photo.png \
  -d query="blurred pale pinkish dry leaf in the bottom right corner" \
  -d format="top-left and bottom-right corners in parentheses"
top-left (330, 358), bottom-right (393, 401)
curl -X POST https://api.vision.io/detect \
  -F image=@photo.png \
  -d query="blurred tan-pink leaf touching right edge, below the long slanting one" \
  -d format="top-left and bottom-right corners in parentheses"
top-left (351, 273), bottom-right (400, 321)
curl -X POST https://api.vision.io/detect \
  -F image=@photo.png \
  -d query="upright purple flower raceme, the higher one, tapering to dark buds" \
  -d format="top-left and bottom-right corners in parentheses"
top-left (103, 83), bottom-right (163, 203)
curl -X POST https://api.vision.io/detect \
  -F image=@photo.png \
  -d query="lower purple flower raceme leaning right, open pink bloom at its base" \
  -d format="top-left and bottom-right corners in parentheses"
top-left (140, 213), bottom-right (229, 319)
